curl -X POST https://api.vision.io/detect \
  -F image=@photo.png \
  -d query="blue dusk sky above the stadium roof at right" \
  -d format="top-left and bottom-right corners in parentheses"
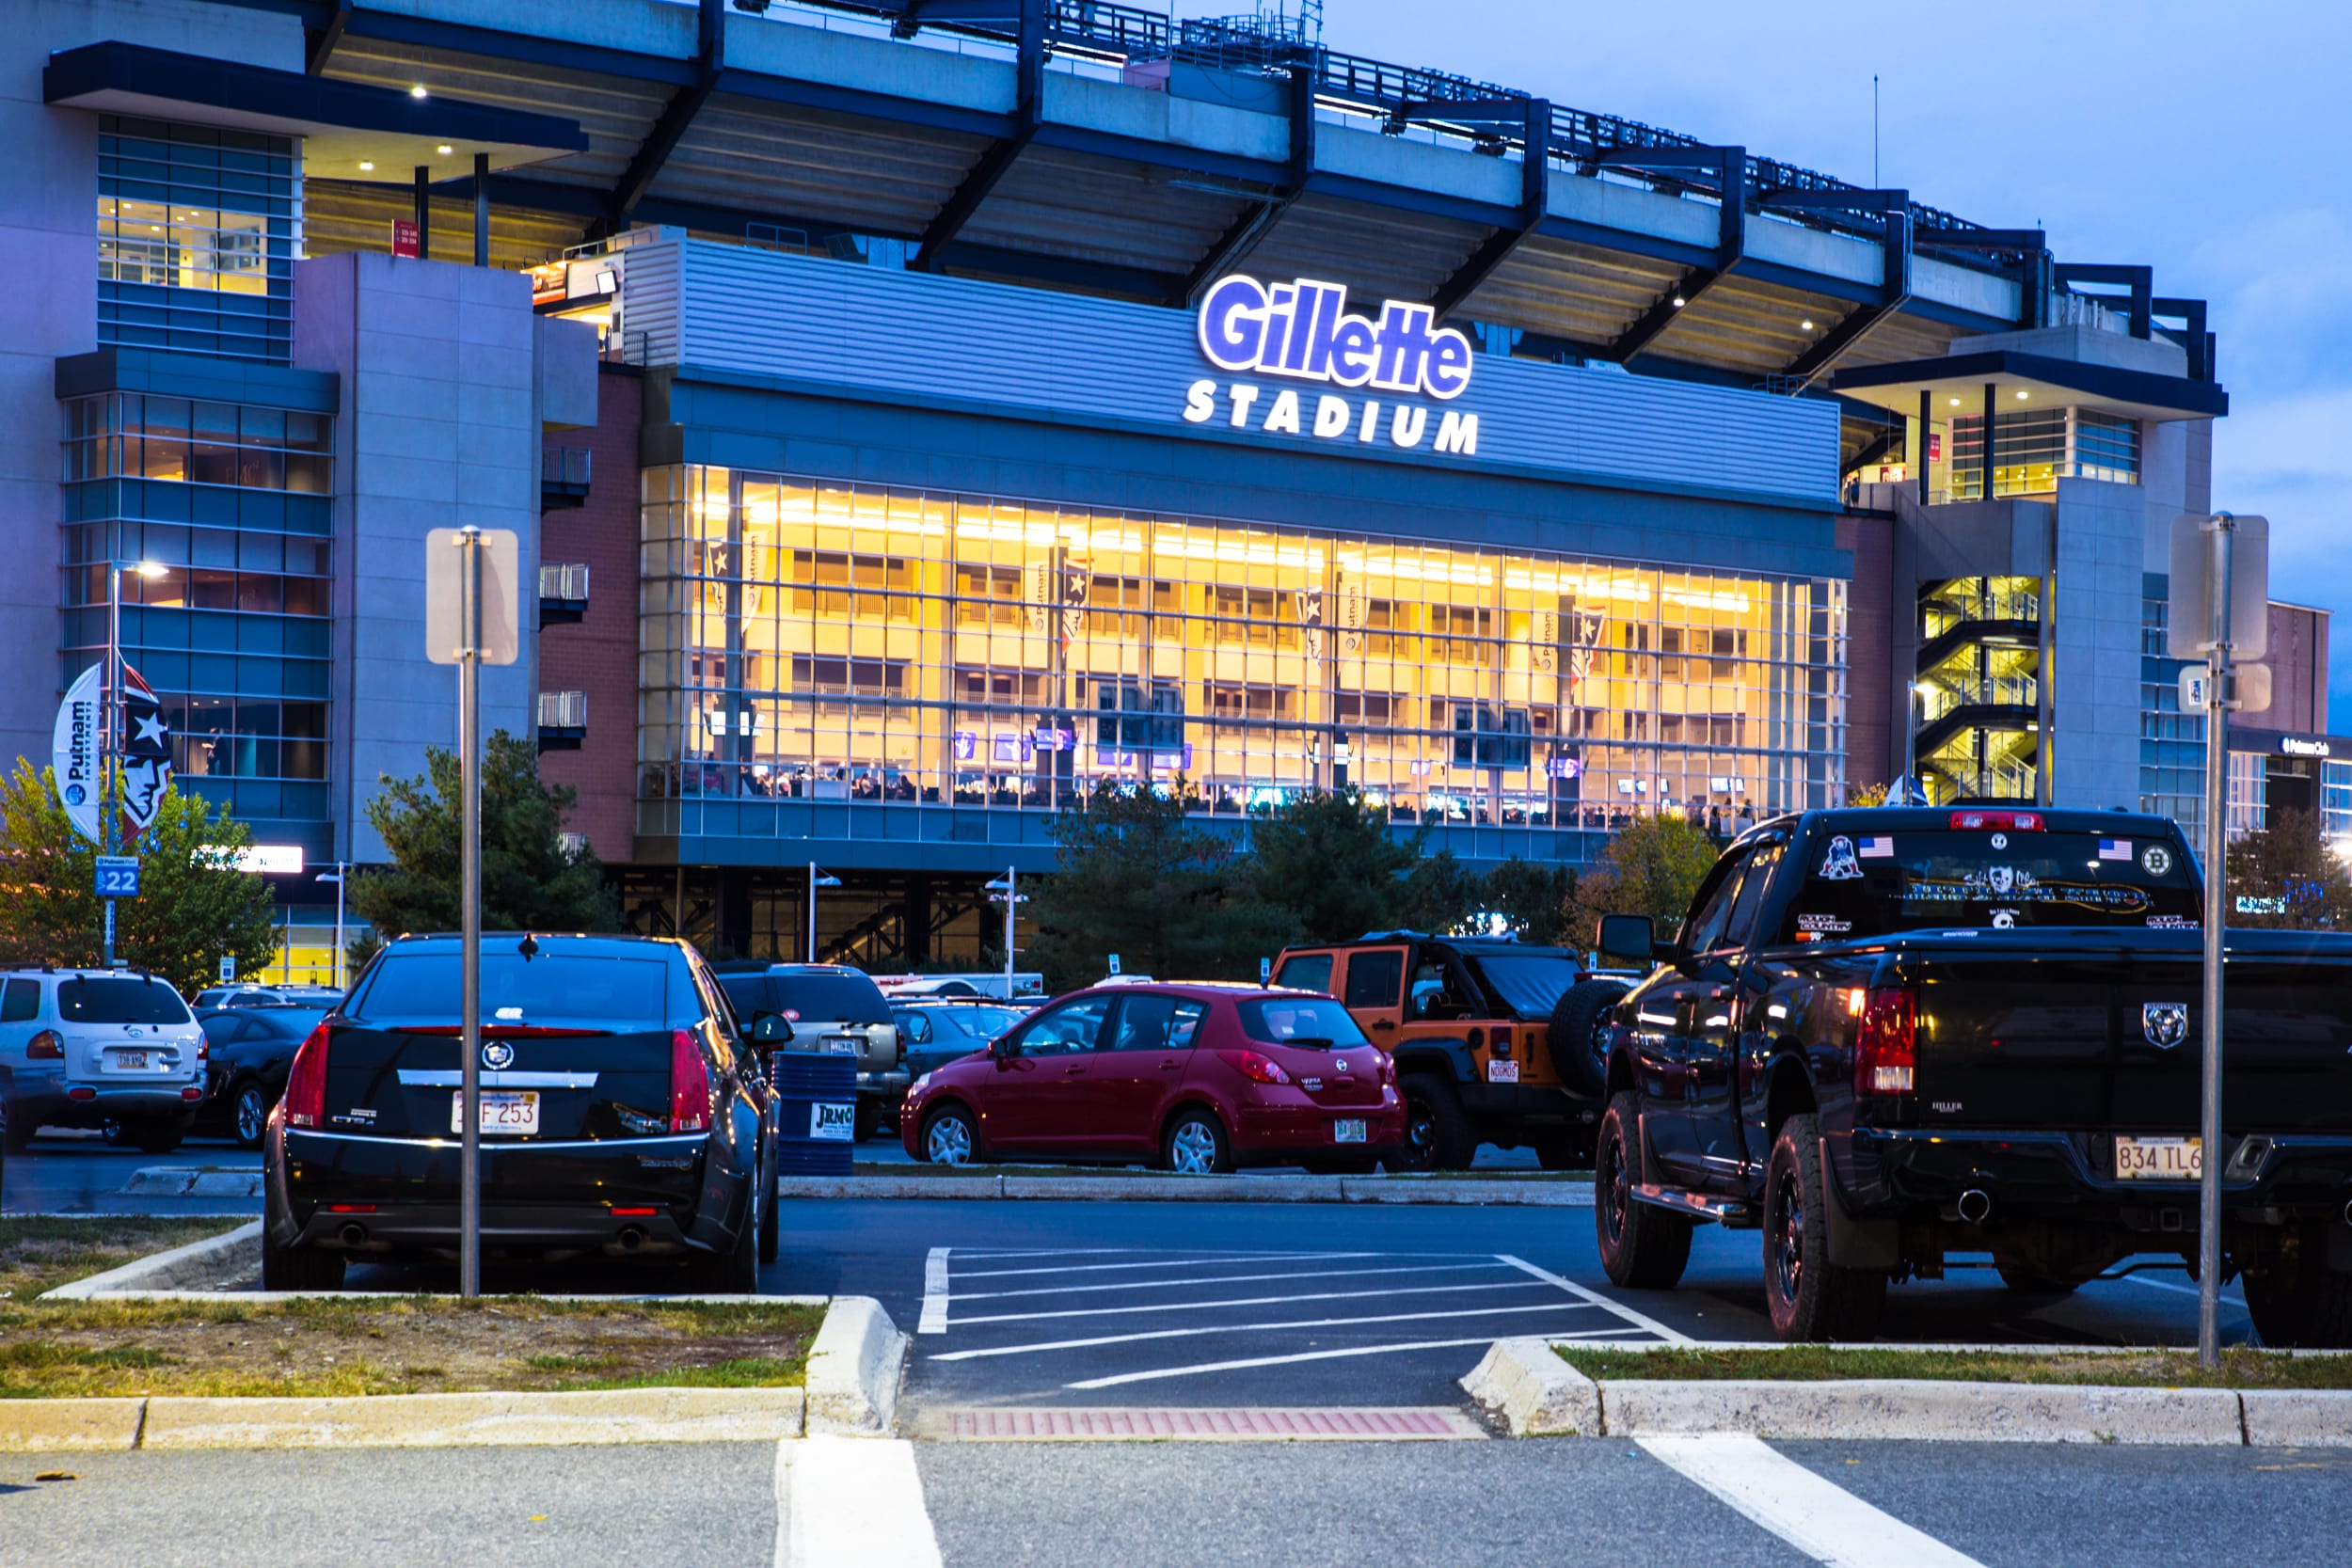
top-left (1279, 0), bottom-right (2352, 709)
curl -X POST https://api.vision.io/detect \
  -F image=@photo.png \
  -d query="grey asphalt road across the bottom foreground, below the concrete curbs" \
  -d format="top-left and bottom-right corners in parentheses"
top-left (0, 1439), bottom-right (2352, 1568)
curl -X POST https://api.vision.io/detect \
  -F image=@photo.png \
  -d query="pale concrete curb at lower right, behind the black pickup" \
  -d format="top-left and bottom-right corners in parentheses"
top-left (1461, 1340), bottom-right (2352, 1449)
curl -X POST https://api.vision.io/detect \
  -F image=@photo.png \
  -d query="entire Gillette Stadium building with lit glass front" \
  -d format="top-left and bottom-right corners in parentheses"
top-left (0, 0), bottom-right (2352, 969)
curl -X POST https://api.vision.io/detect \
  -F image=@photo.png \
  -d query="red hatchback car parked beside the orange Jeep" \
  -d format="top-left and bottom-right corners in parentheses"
top-left (898, 983), bottom-right (1405, 1173)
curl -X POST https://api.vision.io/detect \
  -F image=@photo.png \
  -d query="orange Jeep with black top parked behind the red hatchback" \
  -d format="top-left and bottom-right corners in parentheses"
top-left (1275, 931), bottom-right (1628, 1171)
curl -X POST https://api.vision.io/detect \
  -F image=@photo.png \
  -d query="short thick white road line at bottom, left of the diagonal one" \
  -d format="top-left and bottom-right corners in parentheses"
top-left (776, 1436), bottom-right (941, 1568)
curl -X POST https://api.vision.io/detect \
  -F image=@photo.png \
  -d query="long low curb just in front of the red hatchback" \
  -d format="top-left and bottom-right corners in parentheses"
top-left (776, 1176), bottom-right (1593, 1209)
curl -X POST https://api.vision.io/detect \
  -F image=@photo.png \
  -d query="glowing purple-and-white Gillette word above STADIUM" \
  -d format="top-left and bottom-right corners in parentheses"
top-left (1200, 275), bottom-right (1472, 400)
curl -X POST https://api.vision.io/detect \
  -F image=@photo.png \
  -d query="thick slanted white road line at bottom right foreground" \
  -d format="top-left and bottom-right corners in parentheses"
top-left (1640, 1434), bottom-right (1983, 1568)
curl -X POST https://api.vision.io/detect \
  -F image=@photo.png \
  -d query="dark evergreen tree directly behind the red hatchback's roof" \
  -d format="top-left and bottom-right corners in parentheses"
top-left (1028, 783), bottom-right (1296, 990)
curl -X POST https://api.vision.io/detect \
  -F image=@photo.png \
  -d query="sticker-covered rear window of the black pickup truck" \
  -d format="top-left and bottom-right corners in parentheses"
top-left (1781, 830), bottom-right (2200, 942)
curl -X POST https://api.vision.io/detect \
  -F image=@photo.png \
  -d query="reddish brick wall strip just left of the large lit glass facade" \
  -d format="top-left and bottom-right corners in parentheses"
top-left (539, 369), bottom-right (643, 865)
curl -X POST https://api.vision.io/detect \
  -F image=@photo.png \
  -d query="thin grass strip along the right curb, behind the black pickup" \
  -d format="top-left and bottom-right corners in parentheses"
top-left (1555, 1345), bottom-right (2352, 1389)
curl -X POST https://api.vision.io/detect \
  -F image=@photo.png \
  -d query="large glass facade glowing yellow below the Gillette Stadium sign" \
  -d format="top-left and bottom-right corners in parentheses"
top-left (640, 466), bottom-right (1847, 853)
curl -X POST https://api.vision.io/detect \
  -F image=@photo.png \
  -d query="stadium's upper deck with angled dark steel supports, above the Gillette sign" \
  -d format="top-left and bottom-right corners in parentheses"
top-left (233, 0), bottom-right (2211, 456)
